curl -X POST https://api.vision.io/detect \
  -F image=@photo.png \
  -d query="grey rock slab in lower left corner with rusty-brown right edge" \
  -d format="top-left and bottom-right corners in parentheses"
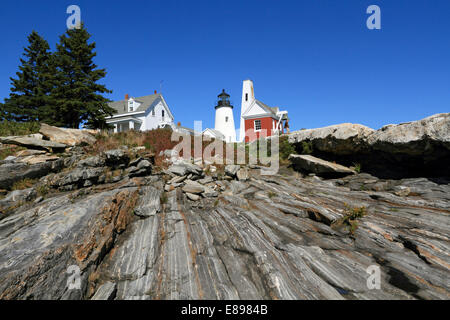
top-left (0, 188), bottom-right (137, 299)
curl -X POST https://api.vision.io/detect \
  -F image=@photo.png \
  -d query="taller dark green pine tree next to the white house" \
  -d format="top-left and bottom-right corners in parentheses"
top-left (52, 24), bottom-right (115, 128)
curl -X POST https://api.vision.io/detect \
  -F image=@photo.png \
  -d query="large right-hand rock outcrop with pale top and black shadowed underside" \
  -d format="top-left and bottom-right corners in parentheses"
top-left (288, 113), bottom-right (450, 178)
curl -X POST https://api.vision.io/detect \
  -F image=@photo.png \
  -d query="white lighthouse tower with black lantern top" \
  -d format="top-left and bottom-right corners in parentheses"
top-left (215, 89), bottom-right (236, 142)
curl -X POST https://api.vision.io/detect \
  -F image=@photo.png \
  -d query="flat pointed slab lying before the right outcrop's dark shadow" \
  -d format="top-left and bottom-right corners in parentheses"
top-left (289, 154), bottom-right (356, 176)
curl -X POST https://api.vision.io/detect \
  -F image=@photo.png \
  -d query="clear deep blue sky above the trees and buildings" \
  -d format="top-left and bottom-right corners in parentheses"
top-left (0, 0), bottom-right (450, 129)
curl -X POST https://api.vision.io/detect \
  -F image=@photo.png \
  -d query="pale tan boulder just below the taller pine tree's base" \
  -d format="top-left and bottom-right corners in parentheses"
top-left (39, 123), bottom-right (96, 146)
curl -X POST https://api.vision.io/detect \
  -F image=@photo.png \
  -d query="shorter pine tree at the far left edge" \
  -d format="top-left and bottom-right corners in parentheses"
top-left (0, 31), bottom-right (53, 122)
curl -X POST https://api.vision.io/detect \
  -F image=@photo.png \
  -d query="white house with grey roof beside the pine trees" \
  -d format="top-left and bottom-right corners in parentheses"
top-left (106, 92), bottom-right (175, 132)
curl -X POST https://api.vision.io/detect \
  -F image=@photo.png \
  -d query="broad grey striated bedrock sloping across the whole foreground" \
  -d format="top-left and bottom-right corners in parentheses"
top-left (0, 161), bottom-right (450, 300)
